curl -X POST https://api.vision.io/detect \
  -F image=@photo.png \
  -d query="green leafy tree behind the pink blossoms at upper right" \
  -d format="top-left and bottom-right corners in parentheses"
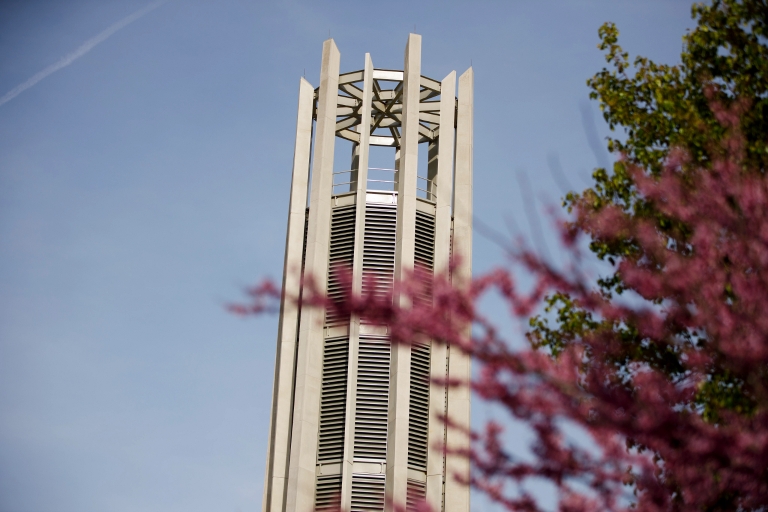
top-left (529, 0), bottom-right (768, 422)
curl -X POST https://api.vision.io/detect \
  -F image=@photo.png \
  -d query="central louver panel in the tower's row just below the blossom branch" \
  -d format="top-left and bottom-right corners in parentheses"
top-left (354, 337), bottom-right (390, 462)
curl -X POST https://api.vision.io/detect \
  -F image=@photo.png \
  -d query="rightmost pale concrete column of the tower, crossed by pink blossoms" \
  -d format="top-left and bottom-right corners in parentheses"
top-left (445, 68), bottom-right (474, 512)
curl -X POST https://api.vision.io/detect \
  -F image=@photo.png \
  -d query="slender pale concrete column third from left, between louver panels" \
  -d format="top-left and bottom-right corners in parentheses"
top-left (341, 53), bottom-right (373, 510)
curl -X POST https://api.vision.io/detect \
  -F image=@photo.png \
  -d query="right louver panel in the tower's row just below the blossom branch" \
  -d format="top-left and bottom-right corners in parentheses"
top-left (408, 343), bottom-right (430, 471)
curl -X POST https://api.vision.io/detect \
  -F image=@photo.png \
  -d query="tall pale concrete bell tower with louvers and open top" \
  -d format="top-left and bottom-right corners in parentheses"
top-left (262, 34), bottom-right (473, 512)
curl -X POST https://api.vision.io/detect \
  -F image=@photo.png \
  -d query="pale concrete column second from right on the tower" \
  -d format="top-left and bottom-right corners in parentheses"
top-left (427, 71), bottom-right (456, 512)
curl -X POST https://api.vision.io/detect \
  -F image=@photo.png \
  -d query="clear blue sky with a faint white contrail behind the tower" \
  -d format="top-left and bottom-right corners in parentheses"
top-left (0, 0), bottom-right (692, 512)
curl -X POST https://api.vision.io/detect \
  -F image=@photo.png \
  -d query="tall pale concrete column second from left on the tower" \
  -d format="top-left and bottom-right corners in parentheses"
top-left (285, 39), bottom-right (340, 512)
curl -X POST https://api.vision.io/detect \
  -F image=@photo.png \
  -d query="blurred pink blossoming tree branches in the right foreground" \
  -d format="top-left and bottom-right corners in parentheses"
top-left (233, 99), bottom-right (768, 511)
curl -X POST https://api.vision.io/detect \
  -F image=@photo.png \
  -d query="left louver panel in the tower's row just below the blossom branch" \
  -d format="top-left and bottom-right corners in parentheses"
top-left (317, 338), bottom-right (349, 463)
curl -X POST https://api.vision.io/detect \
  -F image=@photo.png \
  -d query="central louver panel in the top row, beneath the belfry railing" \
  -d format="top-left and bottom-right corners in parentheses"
top-left (362, 203), bottom-right (397, 304)
